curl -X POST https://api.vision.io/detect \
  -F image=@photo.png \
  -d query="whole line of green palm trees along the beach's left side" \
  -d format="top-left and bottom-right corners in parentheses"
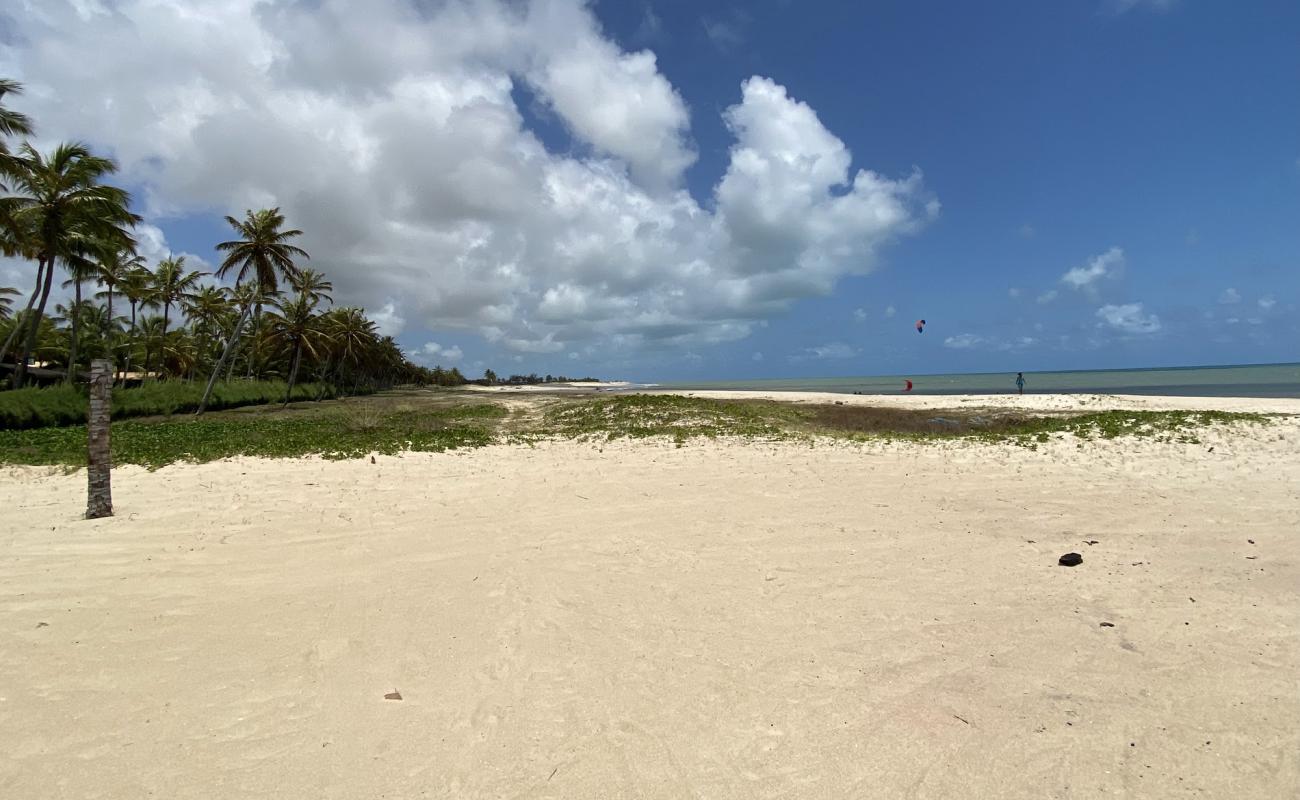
top-left (0, 79), bottom-right (465, 412)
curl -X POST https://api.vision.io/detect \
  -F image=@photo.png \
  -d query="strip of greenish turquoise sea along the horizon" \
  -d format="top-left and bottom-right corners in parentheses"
top-left (664, 364), bottom-right (1300, 397)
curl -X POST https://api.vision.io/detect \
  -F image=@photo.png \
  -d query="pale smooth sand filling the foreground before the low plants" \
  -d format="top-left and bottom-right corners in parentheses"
top-left (0, 393), bottom-right (1300, 800)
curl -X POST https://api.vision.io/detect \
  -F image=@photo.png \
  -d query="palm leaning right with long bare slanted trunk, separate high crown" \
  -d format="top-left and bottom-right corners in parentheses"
top-left (195, 208), bottom-right (311, 414)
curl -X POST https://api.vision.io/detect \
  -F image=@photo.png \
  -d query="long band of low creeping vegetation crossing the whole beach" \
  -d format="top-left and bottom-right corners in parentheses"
top-left (0, 384), bottom-right (1269, 467)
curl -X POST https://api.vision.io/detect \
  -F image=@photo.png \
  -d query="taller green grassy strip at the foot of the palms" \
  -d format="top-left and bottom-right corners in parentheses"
top-left (0, 381), bottom-right (338, 431)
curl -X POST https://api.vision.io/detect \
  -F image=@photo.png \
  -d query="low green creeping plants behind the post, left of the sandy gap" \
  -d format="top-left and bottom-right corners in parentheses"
top-left (0, 405), bottom-right (506, 468)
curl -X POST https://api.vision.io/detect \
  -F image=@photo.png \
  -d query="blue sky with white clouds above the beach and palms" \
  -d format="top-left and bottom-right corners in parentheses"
top-left (0, 0), bottom-right (1300, 381)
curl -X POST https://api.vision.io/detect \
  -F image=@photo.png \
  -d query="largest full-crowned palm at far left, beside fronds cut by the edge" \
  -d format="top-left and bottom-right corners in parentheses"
top-left (0, 144), bottom-right (139, 388)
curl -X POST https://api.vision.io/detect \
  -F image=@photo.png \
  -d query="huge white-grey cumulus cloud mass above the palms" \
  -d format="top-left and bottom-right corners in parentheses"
top-left (0, 0), bottom-right (939, 353)
